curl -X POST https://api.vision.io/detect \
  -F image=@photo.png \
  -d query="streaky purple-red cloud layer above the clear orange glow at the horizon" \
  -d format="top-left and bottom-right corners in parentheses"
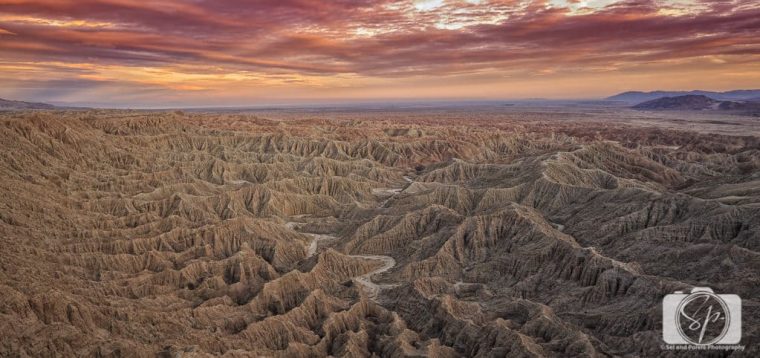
top-left (0, 0), bottom-right (760, 105)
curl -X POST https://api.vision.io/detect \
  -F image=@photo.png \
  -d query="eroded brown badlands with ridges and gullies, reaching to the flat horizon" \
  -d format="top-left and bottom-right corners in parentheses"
top-left (0, 108), bottom-right (760, 357)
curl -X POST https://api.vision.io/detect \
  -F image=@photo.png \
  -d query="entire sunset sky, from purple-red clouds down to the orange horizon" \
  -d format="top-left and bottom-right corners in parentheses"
top-left (0, 0), bottom-right (760, 108)
